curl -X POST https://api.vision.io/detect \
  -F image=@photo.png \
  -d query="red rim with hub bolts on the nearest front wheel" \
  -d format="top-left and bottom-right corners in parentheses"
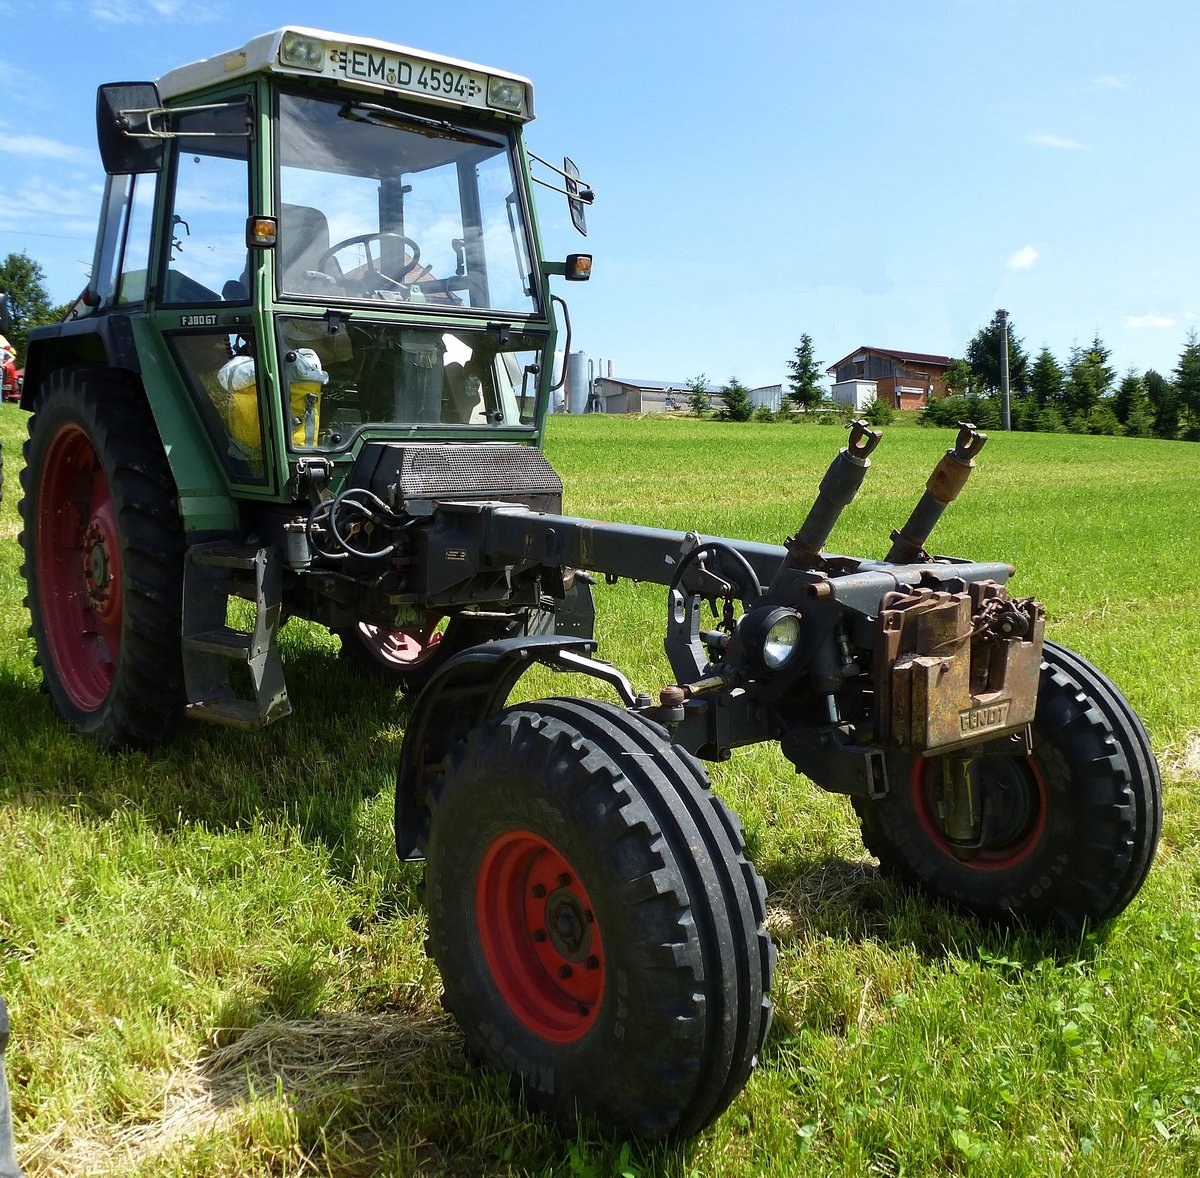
top-left (475, 830), bottom-right (605, 1042)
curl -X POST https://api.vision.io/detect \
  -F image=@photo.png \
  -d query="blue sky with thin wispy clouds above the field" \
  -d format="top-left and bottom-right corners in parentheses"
top-left (0, 0), bottom-right (1200, 386)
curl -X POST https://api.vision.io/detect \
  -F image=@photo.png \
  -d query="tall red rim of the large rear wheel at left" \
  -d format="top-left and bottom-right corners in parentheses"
top-left (36, 425), bottom-right (122, 711)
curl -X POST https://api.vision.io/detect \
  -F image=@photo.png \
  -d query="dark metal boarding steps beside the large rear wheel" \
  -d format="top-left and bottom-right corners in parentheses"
top-left (182, 541), bottom-right (292, 728)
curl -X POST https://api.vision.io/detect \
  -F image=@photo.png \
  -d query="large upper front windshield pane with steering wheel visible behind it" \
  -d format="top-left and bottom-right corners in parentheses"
top-left (277, 94), bottom-right (538, 314)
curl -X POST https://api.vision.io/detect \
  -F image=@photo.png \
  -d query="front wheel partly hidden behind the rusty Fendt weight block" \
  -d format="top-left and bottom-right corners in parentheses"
top-left (854, 642), bottom-right (1163, 930)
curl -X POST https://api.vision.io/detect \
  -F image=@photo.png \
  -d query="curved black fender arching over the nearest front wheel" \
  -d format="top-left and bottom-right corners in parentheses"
top-left (396, 635), bottom-right (635, 861)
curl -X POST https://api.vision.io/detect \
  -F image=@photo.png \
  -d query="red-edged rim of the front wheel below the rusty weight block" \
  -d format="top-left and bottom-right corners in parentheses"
top-left (912, 757), bottom-right (1046, 871)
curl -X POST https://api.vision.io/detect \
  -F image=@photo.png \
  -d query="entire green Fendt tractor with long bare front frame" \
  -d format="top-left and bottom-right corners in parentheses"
top-left (20, 28), bottom-right (1162, 1138)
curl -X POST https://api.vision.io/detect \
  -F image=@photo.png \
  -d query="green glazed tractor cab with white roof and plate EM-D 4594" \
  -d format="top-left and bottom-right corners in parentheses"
top-left (68, 28), bottom-right (589, 500)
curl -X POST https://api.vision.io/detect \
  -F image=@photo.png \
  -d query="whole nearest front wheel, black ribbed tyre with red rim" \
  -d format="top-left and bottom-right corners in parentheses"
top-left (426, 699), bottom-right (774, 1140)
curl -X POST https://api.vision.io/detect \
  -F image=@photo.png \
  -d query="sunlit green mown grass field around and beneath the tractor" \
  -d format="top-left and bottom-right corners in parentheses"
top-left (0, 405), bottom-right (1200, 1178)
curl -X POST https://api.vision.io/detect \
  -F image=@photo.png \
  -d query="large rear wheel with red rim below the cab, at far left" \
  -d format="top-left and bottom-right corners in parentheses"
top-left (19, 369), bottom-right (184, 746)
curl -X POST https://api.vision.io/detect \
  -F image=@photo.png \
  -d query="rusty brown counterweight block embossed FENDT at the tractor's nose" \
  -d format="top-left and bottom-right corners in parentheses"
top-left (875, 581), bottom-right (1045, 753)
